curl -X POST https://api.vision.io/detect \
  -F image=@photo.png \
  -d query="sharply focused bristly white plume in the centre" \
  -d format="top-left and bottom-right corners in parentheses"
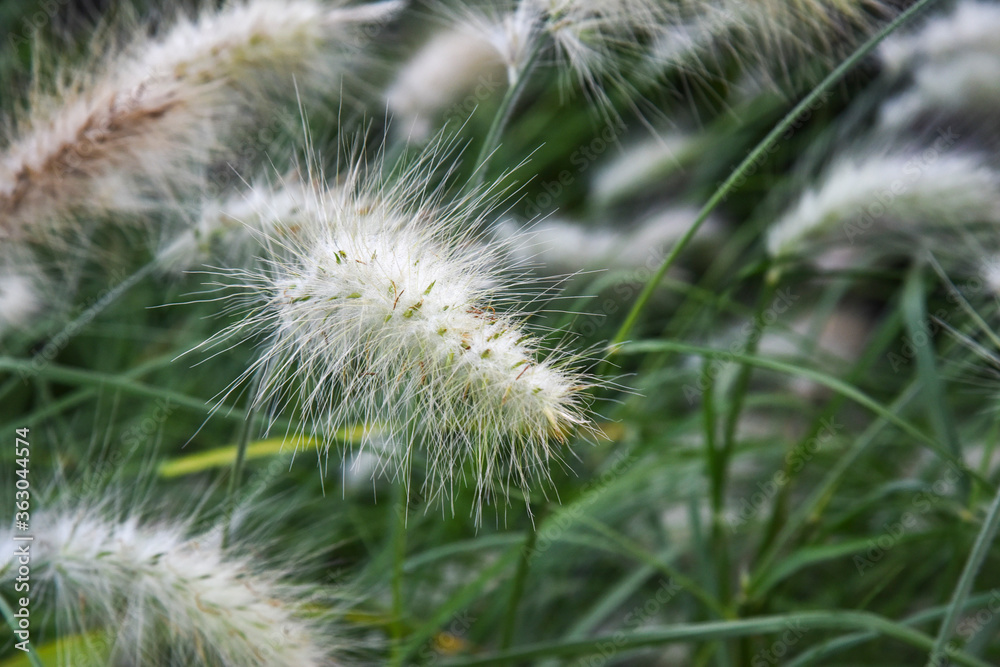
top-left (197, 141), bottom-right (589, 516)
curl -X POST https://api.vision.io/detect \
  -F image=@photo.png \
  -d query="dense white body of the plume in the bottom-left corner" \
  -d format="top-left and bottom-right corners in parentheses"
top-left (0, 508), bottom-right (336, 667)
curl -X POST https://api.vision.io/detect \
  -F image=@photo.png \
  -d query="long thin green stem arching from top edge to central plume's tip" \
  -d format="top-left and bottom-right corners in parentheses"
top-left (608, 0), bottom-right (935, 354)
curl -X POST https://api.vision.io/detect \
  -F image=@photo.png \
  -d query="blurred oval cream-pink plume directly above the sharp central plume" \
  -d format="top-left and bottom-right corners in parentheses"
top-left (385, 26), bottom-right (506, 141)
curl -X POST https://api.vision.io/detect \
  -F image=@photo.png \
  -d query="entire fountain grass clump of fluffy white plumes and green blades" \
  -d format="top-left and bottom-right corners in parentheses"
top-left (11, 0), bottom-right (1000, 667)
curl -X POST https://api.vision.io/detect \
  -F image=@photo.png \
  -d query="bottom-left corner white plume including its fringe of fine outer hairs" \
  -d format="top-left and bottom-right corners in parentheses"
top-left (0, 458), bottom-right (357, 667)
